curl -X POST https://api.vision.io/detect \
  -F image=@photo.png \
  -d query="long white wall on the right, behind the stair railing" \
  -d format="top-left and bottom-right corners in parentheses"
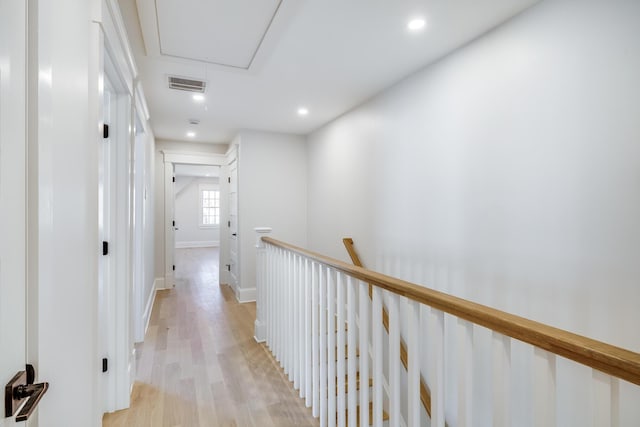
top-left (306, 0), bottom-right (640, 425)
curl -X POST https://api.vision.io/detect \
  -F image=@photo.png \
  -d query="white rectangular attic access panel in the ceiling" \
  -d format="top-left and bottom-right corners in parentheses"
top-left (156, 0), bottom-right (282, 69)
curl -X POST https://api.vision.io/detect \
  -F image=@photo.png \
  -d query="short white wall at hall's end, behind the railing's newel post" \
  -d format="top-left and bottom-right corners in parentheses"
top-left (236, 131), bottom-right (307, 301)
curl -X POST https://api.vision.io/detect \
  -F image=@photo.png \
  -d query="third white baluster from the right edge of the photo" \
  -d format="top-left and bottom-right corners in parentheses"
top-left (492, 332), bottom-right (511, 427)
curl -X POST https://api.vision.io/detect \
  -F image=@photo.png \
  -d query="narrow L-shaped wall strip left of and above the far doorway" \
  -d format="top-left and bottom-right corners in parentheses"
top-left (154, 139), bottom-right (228, 280)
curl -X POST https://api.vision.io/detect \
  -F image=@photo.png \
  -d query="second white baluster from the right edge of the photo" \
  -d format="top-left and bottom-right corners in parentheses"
top-left (532, 347), bottom-right (557, 427)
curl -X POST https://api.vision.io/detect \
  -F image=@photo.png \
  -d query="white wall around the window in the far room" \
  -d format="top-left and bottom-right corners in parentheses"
top-left (175, 176), bottom-right (220, 248)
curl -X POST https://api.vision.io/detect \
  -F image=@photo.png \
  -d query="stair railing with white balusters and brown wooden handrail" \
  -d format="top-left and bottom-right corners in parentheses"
top-left (256, 231), bottom-right (640, 427)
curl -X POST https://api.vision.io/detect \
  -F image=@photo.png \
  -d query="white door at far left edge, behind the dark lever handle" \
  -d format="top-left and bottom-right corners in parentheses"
top-left (0, 0), bottom-right (28, 427)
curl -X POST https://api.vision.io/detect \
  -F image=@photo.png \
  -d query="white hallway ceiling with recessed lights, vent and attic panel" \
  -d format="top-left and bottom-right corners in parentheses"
top-left (119, 0), bottom-right (538, 143)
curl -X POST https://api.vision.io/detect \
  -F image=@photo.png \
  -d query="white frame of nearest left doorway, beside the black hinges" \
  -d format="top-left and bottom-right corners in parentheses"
top-left (94, 0), bottom-right (144, 414)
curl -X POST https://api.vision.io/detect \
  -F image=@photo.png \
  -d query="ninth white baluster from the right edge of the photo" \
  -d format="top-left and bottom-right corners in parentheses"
top-left (360, 282), bottom-right (370, 426)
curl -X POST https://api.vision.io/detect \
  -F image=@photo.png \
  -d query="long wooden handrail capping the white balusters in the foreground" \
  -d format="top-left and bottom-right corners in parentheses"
top-left (262, 237), bottom-right (640, 385)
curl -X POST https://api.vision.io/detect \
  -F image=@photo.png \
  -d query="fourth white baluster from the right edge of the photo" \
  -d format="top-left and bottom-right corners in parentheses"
top-left (458, 318), bottom-right (473, 427)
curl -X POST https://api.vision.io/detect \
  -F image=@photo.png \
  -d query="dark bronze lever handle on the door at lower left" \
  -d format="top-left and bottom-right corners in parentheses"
top-left (4, 365), bottom-right (49, 421)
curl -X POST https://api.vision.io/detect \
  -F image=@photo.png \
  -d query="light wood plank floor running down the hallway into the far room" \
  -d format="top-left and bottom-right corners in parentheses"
top-left (103, 248), bottom-right (319, 427)
